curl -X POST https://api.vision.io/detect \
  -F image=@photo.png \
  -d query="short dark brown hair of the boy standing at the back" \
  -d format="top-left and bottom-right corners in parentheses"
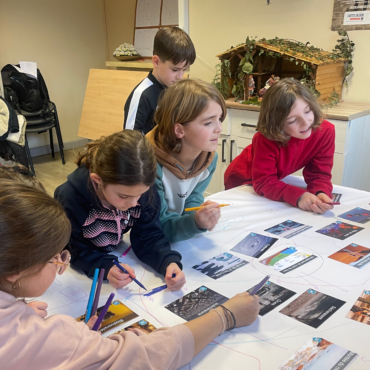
top-left (153, 27), bottom-right (196, 65)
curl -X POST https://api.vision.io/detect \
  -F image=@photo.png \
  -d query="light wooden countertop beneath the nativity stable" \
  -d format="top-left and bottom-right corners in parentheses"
top-left (226, 98), bottom-right (370, 121)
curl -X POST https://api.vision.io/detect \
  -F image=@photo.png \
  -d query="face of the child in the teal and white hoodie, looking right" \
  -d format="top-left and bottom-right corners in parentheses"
top-left (175, 100), bottom-right (222, 152)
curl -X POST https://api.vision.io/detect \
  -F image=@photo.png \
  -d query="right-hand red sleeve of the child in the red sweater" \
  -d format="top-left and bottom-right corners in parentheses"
top-left (303, 124), bottom-right (335, 198)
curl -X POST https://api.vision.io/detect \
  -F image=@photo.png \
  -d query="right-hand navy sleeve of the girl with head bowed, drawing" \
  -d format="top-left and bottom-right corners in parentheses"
top-left (130, 186), bottom-right (182, 275)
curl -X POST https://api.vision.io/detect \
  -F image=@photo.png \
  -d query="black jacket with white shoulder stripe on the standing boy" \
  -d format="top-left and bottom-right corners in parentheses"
top-left (123, 72), bottom-right (166, 135)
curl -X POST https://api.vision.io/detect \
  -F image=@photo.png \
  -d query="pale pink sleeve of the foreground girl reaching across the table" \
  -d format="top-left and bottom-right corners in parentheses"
top-left (26, 315), bottom-right (194, 370)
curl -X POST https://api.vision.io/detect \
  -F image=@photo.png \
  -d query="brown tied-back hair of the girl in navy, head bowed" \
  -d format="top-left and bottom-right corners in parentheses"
top-left (76, 130), bottom-right (157, 186)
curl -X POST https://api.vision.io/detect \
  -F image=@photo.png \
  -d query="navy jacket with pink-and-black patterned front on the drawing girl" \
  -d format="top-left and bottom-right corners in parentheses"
top-left (54, 166), bottom-right (182, 279)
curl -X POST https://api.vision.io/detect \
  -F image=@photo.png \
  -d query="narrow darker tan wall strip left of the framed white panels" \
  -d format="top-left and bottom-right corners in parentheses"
top-left (104, 0), bottom-right (136, 60)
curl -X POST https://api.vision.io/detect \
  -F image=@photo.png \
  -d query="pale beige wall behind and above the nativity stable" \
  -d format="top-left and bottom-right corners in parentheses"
top-left (189, 0), bottom-right (370, 102)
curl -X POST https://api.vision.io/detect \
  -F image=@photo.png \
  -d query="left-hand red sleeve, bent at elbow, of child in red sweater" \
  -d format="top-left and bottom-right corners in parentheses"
top-left (252, 135), bottom-right (305, 207)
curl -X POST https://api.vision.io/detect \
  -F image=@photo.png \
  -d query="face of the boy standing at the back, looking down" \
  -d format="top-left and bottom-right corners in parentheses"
top-left (152, 55), bottom-right (189, 87)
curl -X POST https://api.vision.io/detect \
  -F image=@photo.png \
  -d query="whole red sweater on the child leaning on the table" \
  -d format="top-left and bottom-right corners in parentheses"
top-left (225, 121), bottom-right (335, 206)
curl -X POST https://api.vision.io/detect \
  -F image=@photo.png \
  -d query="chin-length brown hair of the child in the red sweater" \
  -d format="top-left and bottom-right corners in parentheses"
top-left (256, 78), bottom-right (323, 145)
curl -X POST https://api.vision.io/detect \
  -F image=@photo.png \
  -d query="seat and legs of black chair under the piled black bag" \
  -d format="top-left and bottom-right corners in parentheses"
top-left (21, 101), bottom-right (66, 175)
